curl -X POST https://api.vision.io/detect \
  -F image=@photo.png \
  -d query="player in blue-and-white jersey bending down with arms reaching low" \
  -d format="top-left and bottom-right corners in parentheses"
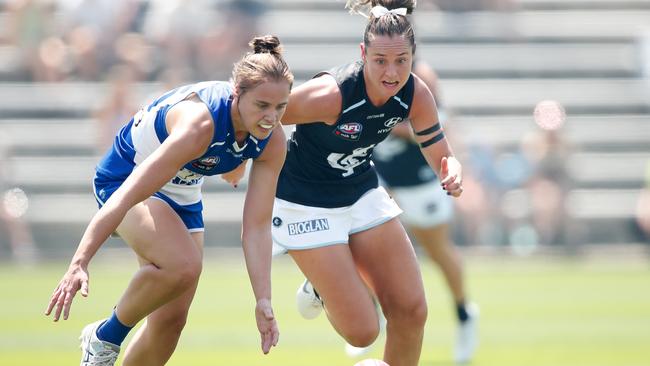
top-left (46, 36), bottom-right (293, 366)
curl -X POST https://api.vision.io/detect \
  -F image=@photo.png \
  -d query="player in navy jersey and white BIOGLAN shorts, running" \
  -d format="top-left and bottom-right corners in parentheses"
top-left (272, 0), bottom-right (462, 366)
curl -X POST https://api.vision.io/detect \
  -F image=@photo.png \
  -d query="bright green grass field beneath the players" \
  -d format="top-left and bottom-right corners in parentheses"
top-left (0, 252), bottom-right (650, 366)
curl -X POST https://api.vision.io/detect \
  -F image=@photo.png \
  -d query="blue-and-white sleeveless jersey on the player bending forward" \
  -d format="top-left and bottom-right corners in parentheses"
top-left (96, 81), bottom-right (270, 206)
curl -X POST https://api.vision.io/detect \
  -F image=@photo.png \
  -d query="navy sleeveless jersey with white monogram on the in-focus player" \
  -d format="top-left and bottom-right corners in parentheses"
top-left (276, 61), bottom-right (414, 208)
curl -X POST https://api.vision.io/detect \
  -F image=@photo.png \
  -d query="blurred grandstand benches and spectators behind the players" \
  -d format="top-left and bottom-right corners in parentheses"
top-left (0, 0), bottom-right (650, 263)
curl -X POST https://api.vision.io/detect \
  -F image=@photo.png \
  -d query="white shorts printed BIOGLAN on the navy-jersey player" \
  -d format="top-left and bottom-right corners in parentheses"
top-left (271, 187), bottom-right (402, 255)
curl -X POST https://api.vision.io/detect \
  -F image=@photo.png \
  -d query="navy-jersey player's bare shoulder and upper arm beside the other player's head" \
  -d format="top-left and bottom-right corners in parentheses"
top-left (282, 74), bottom-right (343, 124)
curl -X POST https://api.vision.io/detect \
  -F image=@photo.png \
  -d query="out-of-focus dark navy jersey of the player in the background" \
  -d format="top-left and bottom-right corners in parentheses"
top-left (372, 110), bottom-right (444, 188)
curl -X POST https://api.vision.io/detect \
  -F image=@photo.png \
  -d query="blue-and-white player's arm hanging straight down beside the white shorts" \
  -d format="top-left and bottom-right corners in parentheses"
top-left (242, 126), bottom-right (286, 354)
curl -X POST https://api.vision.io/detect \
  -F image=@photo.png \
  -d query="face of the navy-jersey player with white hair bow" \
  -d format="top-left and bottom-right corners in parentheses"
top-left (361, 36), bottom-right (413, 99)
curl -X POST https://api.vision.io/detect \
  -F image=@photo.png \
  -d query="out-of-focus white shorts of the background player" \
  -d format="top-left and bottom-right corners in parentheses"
top-left (391, 179), bottom-right (454, 228)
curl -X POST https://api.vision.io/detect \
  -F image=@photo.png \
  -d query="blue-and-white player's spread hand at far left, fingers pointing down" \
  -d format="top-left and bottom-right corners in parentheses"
top-left (45, 265), bottom-right (88, 321)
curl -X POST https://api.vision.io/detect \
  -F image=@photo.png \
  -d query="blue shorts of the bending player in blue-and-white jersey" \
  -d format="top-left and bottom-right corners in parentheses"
top-left (93, 172), bottom-right (205, 232)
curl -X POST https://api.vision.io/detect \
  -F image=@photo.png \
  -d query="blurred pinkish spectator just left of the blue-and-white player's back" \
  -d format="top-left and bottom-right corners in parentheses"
top-left (95, 64), bottom-right (138, 154)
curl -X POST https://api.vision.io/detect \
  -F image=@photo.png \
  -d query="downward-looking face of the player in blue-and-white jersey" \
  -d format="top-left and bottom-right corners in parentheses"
top-left (237, 81), bottom-right (290, 139)
